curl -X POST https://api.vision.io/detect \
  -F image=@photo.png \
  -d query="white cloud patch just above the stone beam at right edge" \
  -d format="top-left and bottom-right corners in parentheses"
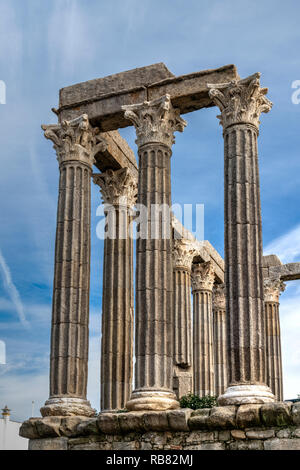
top-left (264, 225), bottom-right (300, 263)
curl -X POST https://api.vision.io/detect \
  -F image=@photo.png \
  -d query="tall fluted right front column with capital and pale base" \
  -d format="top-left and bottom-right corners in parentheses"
top-left (208, 74), bottom-right (274, 405)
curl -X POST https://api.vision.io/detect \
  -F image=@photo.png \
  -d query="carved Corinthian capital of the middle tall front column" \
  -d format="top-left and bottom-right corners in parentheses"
top-left (122, 95), bottom-right (187, 148)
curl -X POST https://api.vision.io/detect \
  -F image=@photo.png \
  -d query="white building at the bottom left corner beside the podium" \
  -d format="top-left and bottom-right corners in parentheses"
top-left (0, 406), bottom-right (28, 450)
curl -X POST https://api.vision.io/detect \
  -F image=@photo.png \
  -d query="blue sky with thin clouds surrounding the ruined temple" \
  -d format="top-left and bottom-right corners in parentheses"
top-left (0, 0), bottom-right (300, 420)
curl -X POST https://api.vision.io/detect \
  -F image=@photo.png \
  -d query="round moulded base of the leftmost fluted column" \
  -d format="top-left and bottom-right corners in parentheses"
top-left (40, 397), bottom-right (96, 417)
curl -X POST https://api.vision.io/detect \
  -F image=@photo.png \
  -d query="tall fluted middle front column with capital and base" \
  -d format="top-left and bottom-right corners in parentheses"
top-left (123, 95), bottom-right (186, 410)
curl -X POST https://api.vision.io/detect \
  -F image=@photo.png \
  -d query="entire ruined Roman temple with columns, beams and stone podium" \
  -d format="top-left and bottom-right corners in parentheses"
top-left (21, 63), bottom-right (300, 449)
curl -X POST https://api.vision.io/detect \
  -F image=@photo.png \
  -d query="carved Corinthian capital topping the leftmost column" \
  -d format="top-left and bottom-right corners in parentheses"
top-left (42, 114), bottom-right (107, 167)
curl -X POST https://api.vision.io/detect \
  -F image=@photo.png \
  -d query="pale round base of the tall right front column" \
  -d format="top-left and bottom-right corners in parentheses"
top-left (218, 384), bottom-right (275, 406)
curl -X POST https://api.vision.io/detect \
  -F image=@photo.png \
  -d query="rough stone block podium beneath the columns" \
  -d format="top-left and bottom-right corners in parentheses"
top-left (20, 403), bottom-right (300, 450)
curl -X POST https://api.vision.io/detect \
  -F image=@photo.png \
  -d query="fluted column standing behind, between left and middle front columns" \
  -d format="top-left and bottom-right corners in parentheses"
top-left (93, 168), bottom-right (137, 411)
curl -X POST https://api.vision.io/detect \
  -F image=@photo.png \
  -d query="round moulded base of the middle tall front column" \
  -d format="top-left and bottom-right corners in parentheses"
top-left (126, 390), bottom-right (179, 411)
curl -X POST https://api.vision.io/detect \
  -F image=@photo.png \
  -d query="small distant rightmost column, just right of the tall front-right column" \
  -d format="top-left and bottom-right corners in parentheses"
top-left (264, 278), bottom-right (285, 401)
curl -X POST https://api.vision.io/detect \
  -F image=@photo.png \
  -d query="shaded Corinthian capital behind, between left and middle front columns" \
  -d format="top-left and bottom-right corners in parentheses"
top-left (93, 168), bottom-right (137, 207)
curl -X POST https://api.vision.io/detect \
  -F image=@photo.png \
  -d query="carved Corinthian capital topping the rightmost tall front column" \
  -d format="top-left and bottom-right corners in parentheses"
top-left (207, 73), bottom-right (272, 129)
